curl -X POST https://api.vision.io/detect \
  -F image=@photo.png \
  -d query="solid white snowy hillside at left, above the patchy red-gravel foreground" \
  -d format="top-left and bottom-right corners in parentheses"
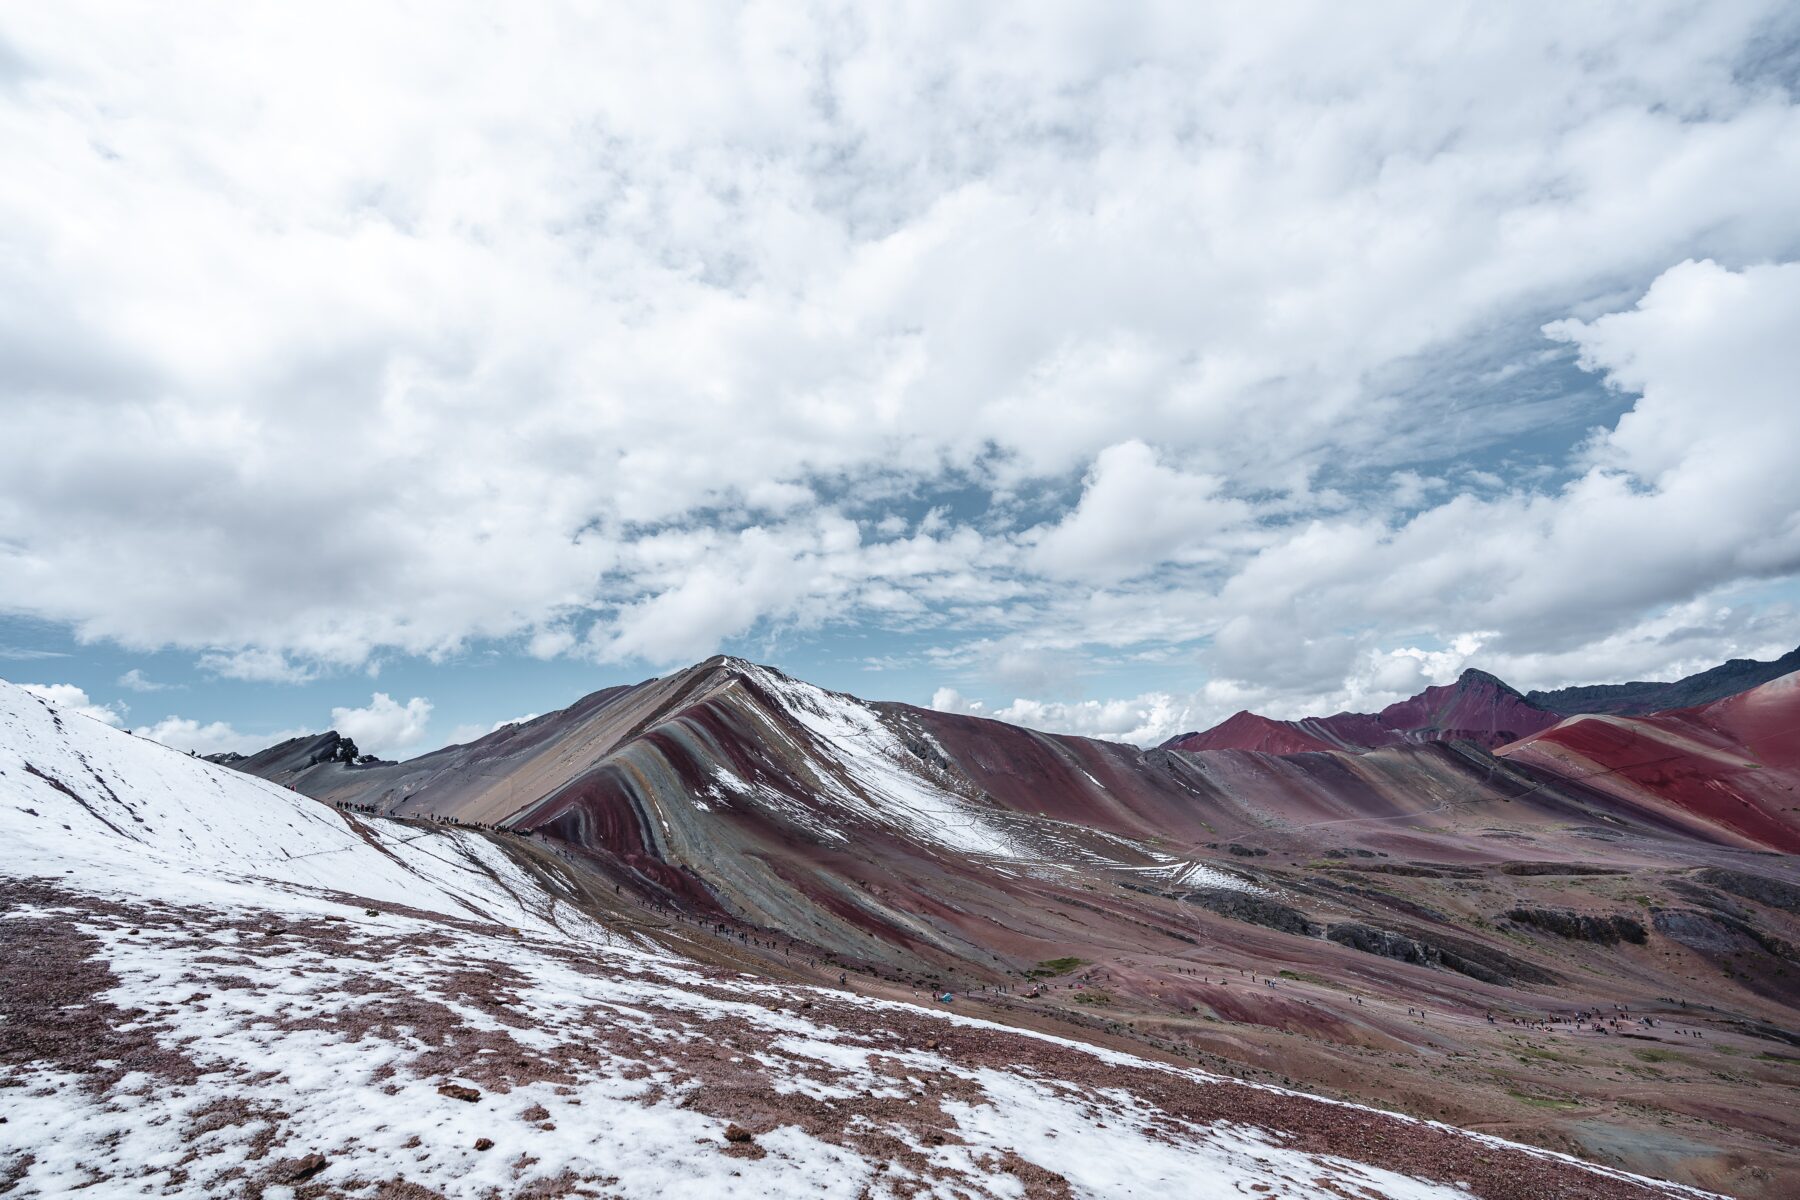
top-left (0, 684), bottom-right (604, 932)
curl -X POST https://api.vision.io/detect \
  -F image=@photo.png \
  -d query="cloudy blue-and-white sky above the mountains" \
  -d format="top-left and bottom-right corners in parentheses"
top-left (0, 0), bottom-right (1800, 756)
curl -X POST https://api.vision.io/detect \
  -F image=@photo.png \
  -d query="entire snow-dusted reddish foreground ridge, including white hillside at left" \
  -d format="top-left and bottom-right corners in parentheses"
top-left (0, 684), bottom-right (1701, 1200)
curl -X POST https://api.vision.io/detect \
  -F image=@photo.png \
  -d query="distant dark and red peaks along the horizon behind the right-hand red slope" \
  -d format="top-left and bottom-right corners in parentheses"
top-left (1163, 648), bottom-right (1800, 754)
